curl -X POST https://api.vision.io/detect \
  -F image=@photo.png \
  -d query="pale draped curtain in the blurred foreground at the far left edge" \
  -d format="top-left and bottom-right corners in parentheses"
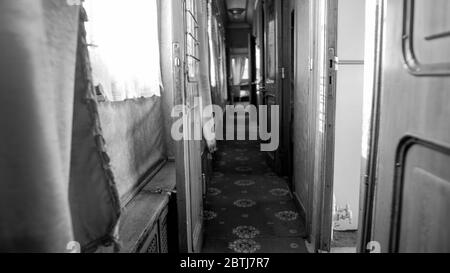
top-left (0, 0), bottom-right (79, 252)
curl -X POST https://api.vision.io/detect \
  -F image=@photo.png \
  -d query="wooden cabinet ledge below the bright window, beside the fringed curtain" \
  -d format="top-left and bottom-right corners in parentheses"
top-left (119, 163), bottom-right (178, 253)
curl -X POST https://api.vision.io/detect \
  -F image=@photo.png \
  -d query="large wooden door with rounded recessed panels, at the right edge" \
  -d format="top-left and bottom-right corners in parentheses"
top-left (363, 0), bottom-right (450, 253)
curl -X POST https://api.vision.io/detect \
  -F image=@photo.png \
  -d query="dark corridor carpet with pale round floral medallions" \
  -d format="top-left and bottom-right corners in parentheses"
top-left (203, 141), bottom-right (306, 253)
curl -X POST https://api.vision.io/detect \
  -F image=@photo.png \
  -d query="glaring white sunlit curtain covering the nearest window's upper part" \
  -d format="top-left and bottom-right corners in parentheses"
top-left (84, 0), bottom-right (162, 101)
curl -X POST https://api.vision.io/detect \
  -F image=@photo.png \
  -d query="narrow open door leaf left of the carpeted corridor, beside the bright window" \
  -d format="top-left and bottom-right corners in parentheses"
top-left (173, 0), bottom-right (206, 253)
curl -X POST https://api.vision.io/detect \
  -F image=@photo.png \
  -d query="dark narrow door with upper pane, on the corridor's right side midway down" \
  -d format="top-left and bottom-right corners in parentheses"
top-left (261, 0), bottom-right (282, 172)
